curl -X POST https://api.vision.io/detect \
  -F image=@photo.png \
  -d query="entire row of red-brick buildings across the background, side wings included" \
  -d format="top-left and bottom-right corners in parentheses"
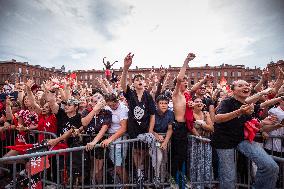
top-left (0, 60), bottom-right (270, 85)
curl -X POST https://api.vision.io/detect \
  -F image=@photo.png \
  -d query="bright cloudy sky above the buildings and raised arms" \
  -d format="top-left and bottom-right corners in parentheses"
top-left (0, 0), bottom-right (284, 70)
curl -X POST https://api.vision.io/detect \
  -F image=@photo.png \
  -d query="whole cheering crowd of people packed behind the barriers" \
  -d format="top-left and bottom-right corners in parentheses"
top-left (0, 53), bottom-right (284, 189)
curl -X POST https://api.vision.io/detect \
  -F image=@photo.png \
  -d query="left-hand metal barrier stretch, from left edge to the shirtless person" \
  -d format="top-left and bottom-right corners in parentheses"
top-left (0, 134), bottom-right (173, 188)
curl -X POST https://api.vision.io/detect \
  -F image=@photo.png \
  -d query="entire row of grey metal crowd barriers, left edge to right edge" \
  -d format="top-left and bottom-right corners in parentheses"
top-left (0, 136), bottom-right (284, 189)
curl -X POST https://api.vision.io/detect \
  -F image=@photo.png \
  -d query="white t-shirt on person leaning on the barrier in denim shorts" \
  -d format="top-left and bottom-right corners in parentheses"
top-left (105, 102), bottom-right (128, 134)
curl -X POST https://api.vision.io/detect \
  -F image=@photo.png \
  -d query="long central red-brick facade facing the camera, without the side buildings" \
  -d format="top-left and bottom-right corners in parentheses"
top-left (75, 64), bottom-right (261, 85)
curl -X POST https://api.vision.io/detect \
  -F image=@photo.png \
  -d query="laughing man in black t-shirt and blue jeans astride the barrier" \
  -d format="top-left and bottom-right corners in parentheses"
top-left (212, 80), bottom-right (279, 189)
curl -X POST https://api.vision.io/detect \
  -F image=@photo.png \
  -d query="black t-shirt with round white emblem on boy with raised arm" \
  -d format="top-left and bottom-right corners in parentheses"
top-left (124, 86), bottom-right (156, 138)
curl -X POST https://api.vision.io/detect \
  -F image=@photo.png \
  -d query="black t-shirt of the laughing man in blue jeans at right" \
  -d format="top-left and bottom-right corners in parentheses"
top-left (211, 97), bottom-right (259, 149)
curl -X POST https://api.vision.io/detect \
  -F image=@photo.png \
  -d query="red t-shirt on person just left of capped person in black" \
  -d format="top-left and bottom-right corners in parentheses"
top-left (37, 114), bottom-right (57, 143)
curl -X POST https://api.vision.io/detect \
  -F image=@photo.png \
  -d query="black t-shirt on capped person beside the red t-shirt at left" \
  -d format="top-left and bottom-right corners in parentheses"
top-left (55, 108), bottom-right (82, 143)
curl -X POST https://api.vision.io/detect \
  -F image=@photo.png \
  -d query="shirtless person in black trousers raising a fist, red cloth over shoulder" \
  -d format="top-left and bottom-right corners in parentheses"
top-left (172, 53), bottom-right (197, 179)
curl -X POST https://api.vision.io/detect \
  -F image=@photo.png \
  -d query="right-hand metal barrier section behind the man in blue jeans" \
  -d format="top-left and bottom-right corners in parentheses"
top-left (187, 135), bottom-right (284, 189)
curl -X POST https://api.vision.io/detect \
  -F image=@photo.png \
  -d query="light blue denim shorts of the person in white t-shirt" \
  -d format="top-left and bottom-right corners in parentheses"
top-left (109, 137), bottom-right (128, 166)
